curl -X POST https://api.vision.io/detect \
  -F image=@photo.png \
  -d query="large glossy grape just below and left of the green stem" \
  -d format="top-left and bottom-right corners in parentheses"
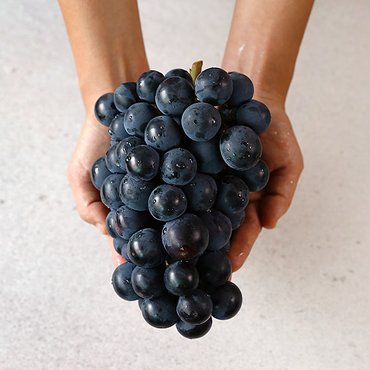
top-left (155, 76), bottom-right (195, 116)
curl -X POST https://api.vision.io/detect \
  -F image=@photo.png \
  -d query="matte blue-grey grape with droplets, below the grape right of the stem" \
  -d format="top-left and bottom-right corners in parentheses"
top-left (181, 103), bottom-right (221, 141)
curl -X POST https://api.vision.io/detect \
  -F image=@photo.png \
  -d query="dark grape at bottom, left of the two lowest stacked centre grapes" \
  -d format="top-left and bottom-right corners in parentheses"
top-left (140, 294), bottom-right (179, 329)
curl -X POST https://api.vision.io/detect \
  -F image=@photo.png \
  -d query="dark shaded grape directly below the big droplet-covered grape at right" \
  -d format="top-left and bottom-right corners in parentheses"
top-left (215, 175), bottom-right (249, 214)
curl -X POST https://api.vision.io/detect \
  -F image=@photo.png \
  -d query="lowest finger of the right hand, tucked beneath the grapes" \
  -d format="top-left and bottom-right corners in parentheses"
top-left (229, 202), bottom-right (262, 272)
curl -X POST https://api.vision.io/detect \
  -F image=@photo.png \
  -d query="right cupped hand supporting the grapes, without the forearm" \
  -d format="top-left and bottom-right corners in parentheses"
top-left (229, 96), bottom-right (303, 271)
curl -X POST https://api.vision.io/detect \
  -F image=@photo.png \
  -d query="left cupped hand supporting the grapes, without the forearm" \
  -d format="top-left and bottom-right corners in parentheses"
top-left (67, 116), bottom-right (124, 267)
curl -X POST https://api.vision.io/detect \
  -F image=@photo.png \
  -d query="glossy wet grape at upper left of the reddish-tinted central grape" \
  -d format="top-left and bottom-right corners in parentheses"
top-left (148, 184), bottom-right (188, 222)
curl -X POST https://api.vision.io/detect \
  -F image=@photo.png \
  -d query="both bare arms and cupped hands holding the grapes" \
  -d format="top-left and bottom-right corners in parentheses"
top-left (59, 0), bottom-right (313, 271)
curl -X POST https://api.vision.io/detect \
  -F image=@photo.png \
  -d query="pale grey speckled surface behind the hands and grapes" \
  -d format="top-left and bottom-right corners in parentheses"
top-left (0, 0), bottom-right (370, 370)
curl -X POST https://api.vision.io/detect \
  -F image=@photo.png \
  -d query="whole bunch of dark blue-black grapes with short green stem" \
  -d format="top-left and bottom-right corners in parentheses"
top-left (91, 62), bottom-right (271, 338)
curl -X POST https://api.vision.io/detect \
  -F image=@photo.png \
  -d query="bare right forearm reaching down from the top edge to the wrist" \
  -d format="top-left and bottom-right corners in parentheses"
top-left (224, 0), bottom-right (313, 104)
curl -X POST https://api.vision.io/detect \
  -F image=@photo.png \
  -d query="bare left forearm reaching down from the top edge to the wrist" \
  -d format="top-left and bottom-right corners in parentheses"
top-left (59, 0), bottom-right (148, 114)
